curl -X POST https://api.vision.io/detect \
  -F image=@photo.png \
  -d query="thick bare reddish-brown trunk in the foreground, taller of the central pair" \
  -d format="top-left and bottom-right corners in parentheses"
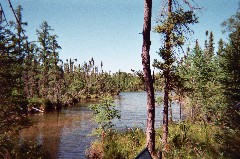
top-left (142, 0), bottom-right (155, 154)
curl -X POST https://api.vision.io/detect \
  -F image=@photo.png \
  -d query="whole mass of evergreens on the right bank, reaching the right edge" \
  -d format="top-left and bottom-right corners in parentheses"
top-left (165, 8), bottom-right (240, 158)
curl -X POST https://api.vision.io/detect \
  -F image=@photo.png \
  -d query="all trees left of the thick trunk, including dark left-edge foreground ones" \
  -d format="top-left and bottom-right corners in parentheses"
top-left (0, 6), bottom-right (148, 158)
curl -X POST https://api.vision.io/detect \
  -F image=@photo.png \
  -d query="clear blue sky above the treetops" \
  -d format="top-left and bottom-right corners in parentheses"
top-left (0, 0), bottom-right (239, 72)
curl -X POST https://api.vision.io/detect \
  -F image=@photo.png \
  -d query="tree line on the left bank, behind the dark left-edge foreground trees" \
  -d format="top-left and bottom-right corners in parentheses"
top-left (1, 6), bottom-right (152, 113)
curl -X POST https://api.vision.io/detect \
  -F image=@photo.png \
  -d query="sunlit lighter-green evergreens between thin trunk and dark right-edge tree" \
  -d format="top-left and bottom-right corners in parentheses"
top-left (178, 36), bottom-right (228, 122)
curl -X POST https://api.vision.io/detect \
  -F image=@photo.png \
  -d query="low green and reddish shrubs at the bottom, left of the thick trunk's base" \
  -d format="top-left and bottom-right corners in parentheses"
top-left (86, 128), bottom-right (146, 159)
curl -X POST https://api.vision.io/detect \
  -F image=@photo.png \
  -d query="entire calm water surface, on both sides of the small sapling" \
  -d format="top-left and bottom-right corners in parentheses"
top-left (21, 92), bottom-right (179, 159)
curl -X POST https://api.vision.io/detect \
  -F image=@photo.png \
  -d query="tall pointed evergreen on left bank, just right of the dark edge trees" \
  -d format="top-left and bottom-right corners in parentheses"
top-left (37, 21), bottom-right (62, 108)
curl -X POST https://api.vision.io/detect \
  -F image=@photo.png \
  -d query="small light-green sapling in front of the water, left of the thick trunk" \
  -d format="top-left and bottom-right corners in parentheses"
top-left (89, 96), bottom-right (121, 136)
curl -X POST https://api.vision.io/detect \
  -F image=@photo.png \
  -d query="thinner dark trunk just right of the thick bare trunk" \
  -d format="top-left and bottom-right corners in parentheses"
top-left (162, 0), bottom-right (172, 149)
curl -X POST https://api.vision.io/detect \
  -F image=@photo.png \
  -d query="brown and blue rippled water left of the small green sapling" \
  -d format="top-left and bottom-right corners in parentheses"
top-left (21, 105), bottom-right (94, 159)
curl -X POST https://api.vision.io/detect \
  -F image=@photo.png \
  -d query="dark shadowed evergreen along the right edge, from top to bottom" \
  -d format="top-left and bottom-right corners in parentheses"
top-left (218, 9), bottom-right (240, 158)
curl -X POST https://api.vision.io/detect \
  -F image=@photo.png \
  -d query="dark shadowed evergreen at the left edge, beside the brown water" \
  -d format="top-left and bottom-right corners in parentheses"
top-left (0, 9), bottom-right (30, 158)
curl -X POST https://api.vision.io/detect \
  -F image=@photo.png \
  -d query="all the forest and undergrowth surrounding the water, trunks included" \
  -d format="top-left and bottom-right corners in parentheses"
top-left (0, 0), bottom-right (240, 159)
